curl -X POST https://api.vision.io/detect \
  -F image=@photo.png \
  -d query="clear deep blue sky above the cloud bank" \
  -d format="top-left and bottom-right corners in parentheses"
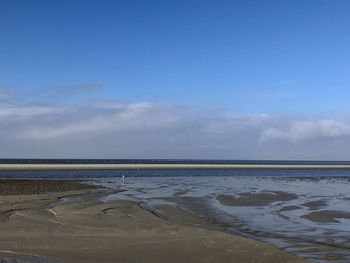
top-left (0, 0), bottom-right (350, 115)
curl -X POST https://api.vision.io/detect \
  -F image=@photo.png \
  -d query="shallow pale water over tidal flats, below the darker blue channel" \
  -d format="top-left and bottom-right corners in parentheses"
top-left (96, 174), bottom-right (350, 263)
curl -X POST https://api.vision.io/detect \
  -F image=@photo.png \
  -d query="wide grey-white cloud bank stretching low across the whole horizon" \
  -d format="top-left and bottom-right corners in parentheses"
top-left (0, 92), bottom-right (350, 159)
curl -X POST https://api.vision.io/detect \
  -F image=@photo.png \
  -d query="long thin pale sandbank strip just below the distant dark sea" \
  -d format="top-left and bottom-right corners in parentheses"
top-left (0, 163), bottom-right (350, 171)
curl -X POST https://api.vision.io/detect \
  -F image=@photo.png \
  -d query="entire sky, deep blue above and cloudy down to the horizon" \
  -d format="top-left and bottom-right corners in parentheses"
top-left (0, 0), bottom-right (350, 159)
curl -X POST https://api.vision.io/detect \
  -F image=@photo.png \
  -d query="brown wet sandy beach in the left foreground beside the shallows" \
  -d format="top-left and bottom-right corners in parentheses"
top-left (0, 180), bottom-right (306, 263)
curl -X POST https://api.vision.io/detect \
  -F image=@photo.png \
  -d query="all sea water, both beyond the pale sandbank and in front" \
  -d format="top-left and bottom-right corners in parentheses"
top-left (0, 159), bottom-right (350, 263)
